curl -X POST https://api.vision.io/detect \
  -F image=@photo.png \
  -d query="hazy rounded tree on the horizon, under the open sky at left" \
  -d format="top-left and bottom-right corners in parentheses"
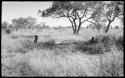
top-left (12, 17), bottom-right (36, 29)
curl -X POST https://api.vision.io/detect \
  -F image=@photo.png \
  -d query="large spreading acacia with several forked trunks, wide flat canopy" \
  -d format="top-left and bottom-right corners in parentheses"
top-left (38, 1), bottom-right (103, 34)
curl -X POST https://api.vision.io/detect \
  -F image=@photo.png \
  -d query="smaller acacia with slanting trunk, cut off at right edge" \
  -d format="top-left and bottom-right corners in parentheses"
top-left (105, 1), bottom-right (124, 33)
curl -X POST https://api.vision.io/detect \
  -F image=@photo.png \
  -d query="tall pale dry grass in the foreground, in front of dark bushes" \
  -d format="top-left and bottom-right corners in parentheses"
top-left (1, 28), bottom-right (124, 77)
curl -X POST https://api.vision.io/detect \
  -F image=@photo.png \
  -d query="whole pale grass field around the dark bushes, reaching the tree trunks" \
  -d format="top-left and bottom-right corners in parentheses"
top-left (1, 29), bottom-right (123, 77)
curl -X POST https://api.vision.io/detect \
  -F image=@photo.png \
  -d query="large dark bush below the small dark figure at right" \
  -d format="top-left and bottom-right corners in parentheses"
top-left (76, 36), bottom-right (115, 54)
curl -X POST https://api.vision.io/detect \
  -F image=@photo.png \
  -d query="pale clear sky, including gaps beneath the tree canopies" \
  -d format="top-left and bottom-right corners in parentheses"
top-left (2, 1), bottom-right (122, 26)
